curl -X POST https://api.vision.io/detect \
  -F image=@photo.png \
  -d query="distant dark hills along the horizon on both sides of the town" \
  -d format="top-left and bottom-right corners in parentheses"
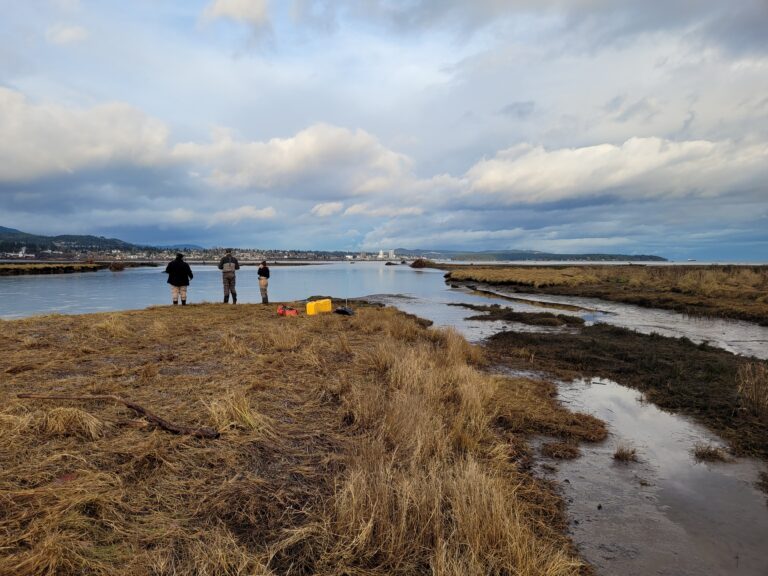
top-left (0, 226), bottom-right (666, 262)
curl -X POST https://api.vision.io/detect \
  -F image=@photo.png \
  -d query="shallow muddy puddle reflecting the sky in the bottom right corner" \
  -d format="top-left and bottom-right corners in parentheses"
top-left (542, 379), bottom-right (768, 576)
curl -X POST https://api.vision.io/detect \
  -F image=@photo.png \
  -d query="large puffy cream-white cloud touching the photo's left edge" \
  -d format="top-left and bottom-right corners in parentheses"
top-left (0, 87), bottom-right (168, 182)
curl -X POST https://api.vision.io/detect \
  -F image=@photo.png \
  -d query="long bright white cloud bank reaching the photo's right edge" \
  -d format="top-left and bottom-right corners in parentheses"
top-left (464, 138), bottom-right (768, 203)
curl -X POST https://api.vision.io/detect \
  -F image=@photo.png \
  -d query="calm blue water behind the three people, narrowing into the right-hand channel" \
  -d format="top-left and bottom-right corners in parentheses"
top-left (0, 262), bottom-right (768, 358)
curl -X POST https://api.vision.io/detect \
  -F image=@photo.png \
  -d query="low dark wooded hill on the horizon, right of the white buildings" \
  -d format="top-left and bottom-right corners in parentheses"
top-left (395, 248), bottom-right (667, 262)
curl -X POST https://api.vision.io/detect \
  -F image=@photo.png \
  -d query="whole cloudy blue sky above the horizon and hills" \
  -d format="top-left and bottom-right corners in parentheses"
top-left (0, 0), bottom-right (768, 261)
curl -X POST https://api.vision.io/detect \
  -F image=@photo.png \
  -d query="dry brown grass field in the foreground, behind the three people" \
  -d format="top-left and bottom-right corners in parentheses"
top-left (0, 304), bottom-right (606, 576)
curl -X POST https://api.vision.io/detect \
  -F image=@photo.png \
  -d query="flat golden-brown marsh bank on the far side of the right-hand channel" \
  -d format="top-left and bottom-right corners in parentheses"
top-left (449, 266), bottom-right (768, 326)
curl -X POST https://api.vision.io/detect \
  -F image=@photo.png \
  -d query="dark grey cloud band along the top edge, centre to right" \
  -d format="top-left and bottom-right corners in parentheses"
top-left (294, 0), bottom-right (768, 54)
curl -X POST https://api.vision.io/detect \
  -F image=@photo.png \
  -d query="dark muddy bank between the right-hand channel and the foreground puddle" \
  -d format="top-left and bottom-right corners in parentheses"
top-left (488, 324), bottom-right (768, 458)
